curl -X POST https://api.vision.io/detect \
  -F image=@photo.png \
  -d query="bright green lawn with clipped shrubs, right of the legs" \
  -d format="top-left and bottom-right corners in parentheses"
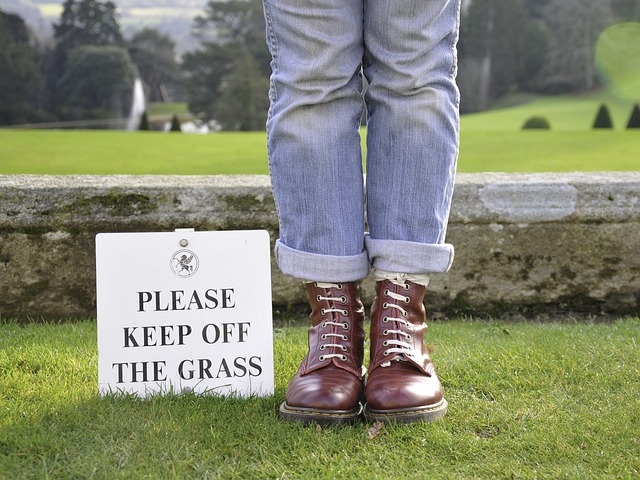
top-left (458, 92), bottom-right (640, 172)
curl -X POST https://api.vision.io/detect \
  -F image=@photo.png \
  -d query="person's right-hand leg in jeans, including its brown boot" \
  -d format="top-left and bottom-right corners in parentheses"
top-left (364, 0), bottom-right (459, 422)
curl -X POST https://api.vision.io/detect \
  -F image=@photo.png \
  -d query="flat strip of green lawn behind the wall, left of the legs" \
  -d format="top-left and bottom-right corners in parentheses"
top-left (0, 130), bottom-right (268, 175)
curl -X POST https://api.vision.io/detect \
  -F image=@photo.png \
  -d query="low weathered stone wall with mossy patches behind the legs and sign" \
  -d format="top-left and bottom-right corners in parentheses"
top-left (0, 172), bottom-right (640, 318)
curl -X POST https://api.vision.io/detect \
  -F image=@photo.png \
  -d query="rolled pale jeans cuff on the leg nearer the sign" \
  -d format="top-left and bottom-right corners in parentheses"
top-left (275, 240), bottom-right (369, 282)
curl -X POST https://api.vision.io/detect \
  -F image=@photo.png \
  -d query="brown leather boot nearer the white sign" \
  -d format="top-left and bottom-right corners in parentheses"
top-left (280, 282), bottom-right (364, 424)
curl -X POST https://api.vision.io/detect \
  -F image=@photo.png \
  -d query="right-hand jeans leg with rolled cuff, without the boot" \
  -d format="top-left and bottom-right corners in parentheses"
top-left (364, 0), bottom-right (459, 273)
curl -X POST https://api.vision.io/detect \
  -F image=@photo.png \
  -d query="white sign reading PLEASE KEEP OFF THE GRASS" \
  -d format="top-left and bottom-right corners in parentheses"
top-left (96, 229), bottom-right (274, 396)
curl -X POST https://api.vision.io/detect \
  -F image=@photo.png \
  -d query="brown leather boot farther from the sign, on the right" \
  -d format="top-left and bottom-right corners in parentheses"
top-left (364, 280), bottom-right (447, 423)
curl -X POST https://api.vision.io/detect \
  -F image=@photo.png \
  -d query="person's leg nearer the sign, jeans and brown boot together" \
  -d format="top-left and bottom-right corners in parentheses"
top-left (264, 0), bottom-right (369, 423)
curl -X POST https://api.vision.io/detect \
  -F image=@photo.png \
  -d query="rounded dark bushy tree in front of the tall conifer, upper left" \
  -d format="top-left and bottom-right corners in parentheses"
top-left (59, 45), bottom-right (137, 119)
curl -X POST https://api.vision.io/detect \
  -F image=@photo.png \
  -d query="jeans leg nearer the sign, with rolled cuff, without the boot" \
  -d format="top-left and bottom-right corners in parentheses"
top-left (264, 0), bottom-right (369, 282)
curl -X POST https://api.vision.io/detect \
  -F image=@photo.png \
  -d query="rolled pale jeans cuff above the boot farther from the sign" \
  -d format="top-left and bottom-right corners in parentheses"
top-left (364, 235), bottom-right (454, 274)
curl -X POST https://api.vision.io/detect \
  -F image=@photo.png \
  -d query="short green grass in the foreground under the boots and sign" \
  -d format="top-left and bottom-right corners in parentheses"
top-left (0, 318), bottom-right (640, 479)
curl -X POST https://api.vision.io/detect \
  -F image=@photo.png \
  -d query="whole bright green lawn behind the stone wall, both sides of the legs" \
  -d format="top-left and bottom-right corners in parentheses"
top-left (0, 94), bottom-right (640, 175)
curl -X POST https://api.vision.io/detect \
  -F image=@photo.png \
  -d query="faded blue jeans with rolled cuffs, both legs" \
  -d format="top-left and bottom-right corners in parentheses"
top-left (264, 0), bottom-right (460, 282)
